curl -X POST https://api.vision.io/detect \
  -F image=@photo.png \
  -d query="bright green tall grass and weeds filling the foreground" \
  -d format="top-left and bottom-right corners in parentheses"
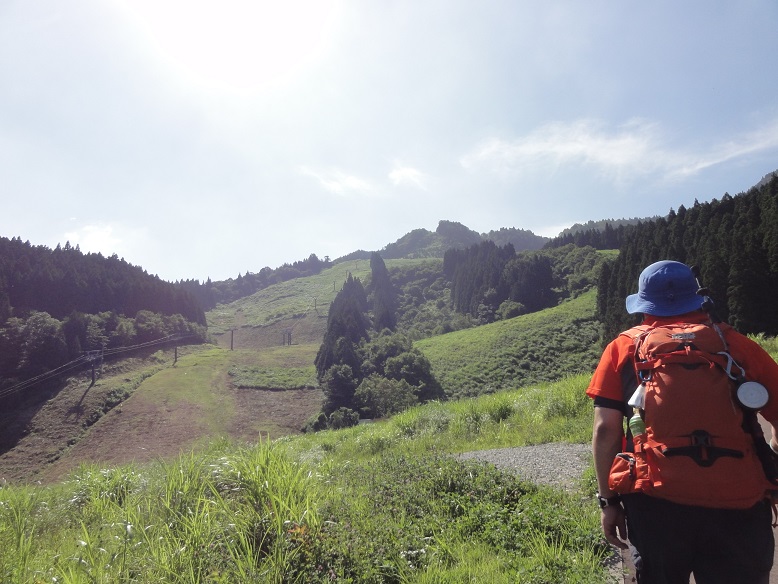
top-left (0, 376), bottom-right (609, 584)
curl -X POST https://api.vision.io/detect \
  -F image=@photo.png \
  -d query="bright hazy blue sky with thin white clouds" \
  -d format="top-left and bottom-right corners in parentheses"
top-left (0, 0), bottom-right (778, 282)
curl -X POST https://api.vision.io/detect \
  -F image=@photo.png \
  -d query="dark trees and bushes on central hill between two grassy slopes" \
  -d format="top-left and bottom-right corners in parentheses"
top-left (309, 241), bottom-right (608, 430)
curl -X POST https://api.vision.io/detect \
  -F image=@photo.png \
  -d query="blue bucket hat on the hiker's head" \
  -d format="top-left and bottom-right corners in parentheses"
top-left (627, 260), bottom-right (705, 316)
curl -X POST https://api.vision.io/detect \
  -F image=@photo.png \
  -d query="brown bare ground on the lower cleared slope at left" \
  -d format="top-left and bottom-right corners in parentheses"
top-left (0, 344), bottom-right (322, 483)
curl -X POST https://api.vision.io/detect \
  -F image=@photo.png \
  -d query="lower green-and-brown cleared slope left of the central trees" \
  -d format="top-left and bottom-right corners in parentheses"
top-left (0, 344), bottom-right (322, 482)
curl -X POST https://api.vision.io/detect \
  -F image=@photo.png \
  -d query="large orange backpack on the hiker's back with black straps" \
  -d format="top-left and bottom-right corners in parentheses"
top-left (609, 323), bottom-right (776, 509)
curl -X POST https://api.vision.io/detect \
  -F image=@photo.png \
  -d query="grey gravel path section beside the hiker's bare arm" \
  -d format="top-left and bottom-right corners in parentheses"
top-left (459, 442), bottom-right (592, 489)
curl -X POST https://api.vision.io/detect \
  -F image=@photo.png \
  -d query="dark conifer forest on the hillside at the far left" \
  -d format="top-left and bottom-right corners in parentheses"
top-left (0, 237), bottom-right (206, 397)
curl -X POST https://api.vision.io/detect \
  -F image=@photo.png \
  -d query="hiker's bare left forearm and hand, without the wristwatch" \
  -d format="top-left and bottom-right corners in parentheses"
top-left (592, 407), bottom-right (627, 549)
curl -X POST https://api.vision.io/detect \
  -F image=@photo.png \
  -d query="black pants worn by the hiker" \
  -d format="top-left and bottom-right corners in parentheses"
top-left (622, 494), bottom-right (775, 584)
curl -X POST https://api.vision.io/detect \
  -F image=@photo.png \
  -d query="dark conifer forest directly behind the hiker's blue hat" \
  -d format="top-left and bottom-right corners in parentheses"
top-left (597, 177), bottom-right (778, 337)
